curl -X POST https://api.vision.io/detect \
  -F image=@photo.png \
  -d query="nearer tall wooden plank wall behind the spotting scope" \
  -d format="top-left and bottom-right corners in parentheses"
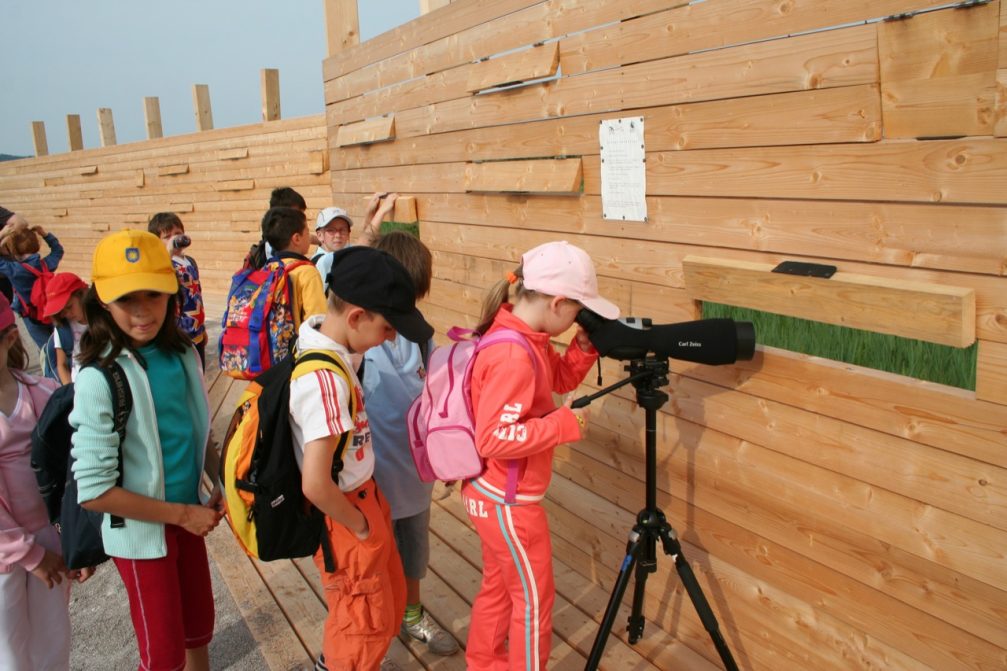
top-left (323, 0), bottom-right (1007, 671)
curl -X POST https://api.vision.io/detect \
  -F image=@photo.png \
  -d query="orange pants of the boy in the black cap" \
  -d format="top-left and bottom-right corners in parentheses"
top-left (314, 480), bottom-right (406, 671)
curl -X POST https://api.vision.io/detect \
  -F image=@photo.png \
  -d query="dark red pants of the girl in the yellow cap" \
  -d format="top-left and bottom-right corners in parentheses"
top-left (113, 524), bottom-right (213, 671)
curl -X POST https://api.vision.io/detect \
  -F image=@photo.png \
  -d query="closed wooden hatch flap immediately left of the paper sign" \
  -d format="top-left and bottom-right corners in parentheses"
top-left (464, 158), bottom-right (583, 193)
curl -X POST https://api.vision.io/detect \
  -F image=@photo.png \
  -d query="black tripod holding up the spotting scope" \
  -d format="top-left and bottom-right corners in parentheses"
top-left (573, 357), bottom-right (738, 671)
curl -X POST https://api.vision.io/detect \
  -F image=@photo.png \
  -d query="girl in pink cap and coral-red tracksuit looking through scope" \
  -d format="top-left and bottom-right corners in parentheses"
top-left (462, 242), bottom-right (619, 669)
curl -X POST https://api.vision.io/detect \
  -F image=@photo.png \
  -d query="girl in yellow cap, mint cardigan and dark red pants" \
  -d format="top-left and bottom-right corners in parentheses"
top-left (69, 231), bottom-right (223, 671)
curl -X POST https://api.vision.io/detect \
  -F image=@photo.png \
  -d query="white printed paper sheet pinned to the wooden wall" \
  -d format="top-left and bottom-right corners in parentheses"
top-left (598, 117), bottom-right (646, 222)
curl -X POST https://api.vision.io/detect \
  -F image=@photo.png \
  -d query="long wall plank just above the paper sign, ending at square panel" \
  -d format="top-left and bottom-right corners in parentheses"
top-left (380, 25), bottom-right (877, 138)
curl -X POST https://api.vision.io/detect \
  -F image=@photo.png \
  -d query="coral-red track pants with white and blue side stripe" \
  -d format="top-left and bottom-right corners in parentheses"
top-left (461, 483), bottom-right (556, 671)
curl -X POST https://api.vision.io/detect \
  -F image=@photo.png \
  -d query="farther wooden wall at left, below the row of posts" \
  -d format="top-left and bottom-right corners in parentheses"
top-left (0, 115), bottom-right (330, 302)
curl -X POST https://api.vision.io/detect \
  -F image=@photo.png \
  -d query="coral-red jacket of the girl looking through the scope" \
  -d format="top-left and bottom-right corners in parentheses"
top-left (472, 304), bottom-right (598, 503)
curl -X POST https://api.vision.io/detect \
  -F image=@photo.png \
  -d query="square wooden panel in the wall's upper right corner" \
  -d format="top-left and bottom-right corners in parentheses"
top-left (878, 2), bottom-right (1000, 138)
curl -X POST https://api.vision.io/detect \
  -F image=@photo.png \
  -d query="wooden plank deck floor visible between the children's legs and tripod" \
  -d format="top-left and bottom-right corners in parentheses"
top-left (200, 360), bottom-right (718, 671)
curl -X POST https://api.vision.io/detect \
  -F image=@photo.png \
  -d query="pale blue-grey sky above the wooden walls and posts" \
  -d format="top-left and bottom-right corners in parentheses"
top-left (0, 0), bottom-right (419, 156)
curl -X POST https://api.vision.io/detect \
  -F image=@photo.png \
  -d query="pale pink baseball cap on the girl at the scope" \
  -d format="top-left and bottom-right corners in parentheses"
top-left (521, 240), bottom-right (619, 319)
